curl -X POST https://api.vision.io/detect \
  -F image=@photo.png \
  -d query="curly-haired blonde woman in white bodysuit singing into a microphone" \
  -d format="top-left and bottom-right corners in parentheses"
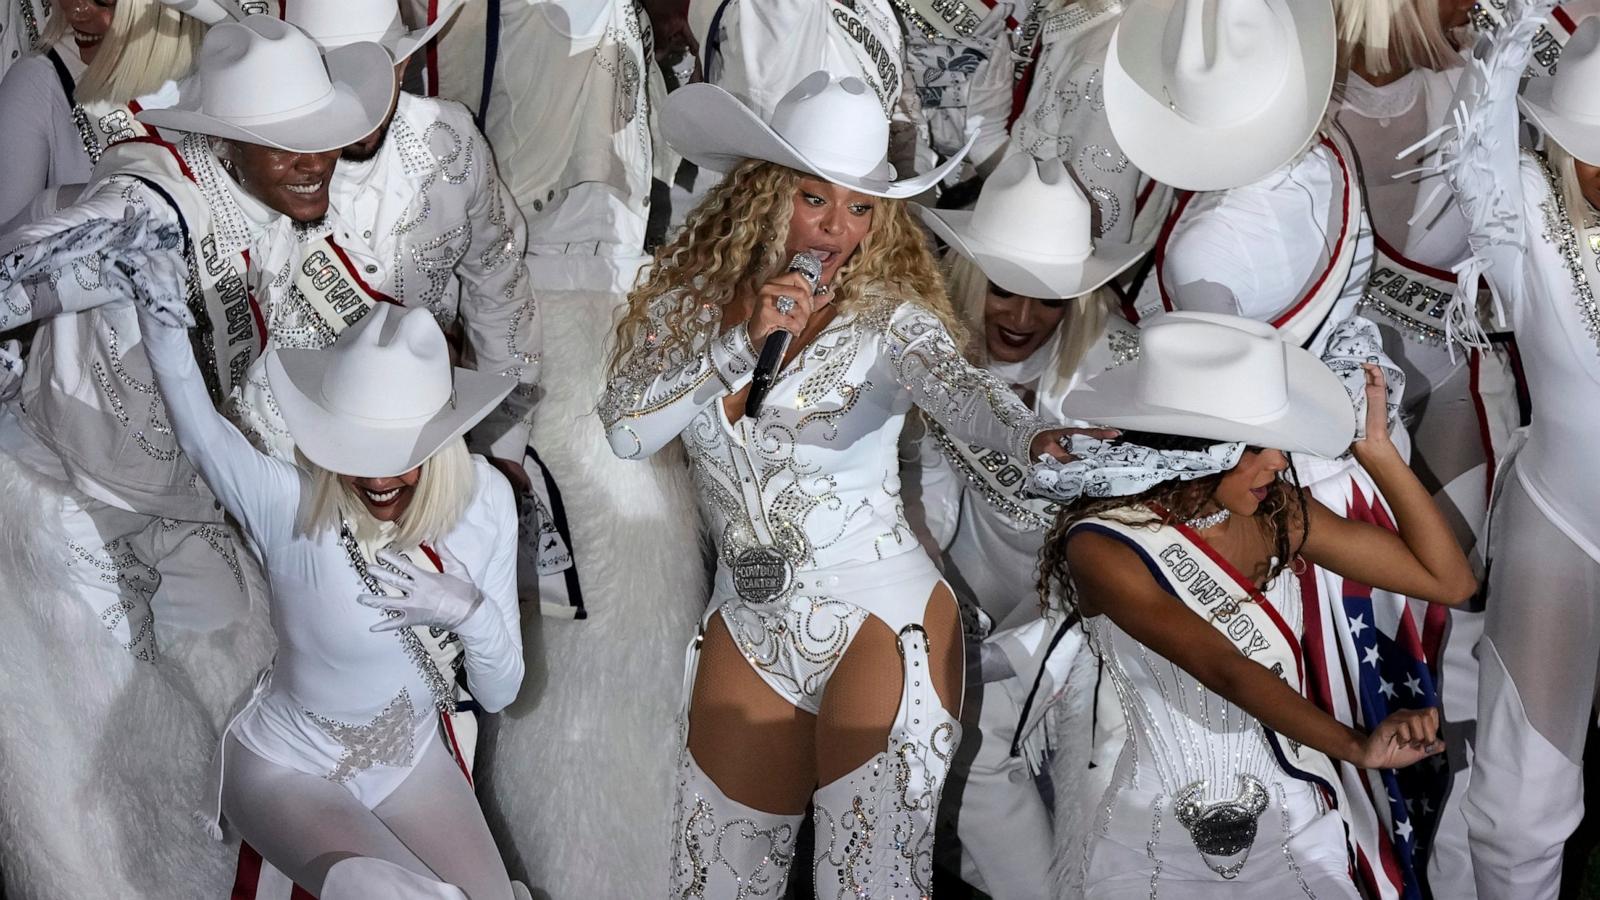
top-left (600, 72), bottom-right (1094, 898)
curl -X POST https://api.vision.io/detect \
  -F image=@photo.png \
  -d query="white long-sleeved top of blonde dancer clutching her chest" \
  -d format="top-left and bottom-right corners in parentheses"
top-left (144, 305), bottom-right (523, 762)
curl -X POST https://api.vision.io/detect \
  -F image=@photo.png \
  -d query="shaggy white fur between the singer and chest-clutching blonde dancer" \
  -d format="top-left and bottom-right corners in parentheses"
top-left (478, 272), bottom-right (709, 900)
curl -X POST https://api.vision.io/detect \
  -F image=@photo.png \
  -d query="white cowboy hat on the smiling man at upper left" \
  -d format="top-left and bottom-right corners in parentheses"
top-left (139, 16), bottom-right (395, 154)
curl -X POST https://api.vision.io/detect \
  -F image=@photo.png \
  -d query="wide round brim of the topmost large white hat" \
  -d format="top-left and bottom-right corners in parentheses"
top-left (1104, 0), bottom-right (1338, 191)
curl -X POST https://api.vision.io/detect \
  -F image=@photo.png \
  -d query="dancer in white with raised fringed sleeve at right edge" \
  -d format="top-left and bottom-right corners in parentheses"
top-left (1442, 0), bottom-right (1600, 900)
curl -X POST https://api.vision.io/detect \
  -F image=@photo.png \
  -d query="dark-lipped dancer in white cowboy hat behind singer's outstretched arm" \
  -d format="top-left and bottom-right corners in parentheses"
top-left (917, 154), bottom-right (1141, 900)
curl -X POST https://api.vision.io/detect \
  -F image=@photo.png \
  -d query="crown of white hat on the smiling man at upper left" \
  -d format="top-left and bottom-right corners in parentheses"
top-left (194, 15), bottom-right (342, 125)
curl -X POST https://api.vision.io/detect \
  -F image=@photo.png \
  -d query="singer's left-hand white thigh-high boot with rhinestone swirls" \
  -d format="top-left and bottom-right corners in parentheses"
top-left (672, 748), bottom-right (803, 900)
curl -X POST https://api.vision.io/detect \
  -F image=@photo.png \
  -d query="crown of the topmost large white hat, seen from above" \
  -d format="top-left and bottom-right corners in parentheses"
top-left (1160, 0), bottom-right (1292, 127)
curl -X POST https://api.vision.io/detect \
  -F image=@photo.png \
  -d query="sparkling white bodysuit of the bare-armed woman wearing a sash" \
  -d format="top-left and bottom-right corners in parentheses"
top-left (1085, 577), bottom-right (1357, 900)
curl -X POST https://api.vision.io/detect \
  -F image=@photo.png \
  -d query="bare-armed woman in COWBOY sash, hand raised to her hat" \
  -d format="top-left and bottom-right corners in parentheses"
top-left (1034, 312), bottom-right (1477, 898)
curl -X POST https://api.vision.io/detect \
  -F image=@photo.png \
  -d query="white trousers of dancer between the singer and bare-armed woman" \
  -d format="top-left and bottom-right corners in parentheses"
top-left (952, 676), bottom-right (1053, 900)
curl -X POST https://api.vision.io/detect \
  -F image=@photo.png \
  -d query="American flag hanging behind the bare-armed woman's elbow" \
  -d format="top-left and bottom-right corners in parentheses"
top-left (1299, 469), bottom-right (1450, 900)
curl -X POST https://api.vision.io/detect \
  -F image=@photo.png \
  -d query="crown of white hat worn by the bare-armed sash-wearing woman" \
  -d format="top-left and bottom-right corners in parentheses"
top-left (1134, 312), bottom-right (1290, 423)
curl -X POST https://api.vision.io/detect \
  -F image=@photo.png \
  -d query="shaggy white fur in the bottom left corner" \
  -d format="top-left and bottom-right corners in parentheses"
top-left (0, 445), bottom-right (272, 900)
